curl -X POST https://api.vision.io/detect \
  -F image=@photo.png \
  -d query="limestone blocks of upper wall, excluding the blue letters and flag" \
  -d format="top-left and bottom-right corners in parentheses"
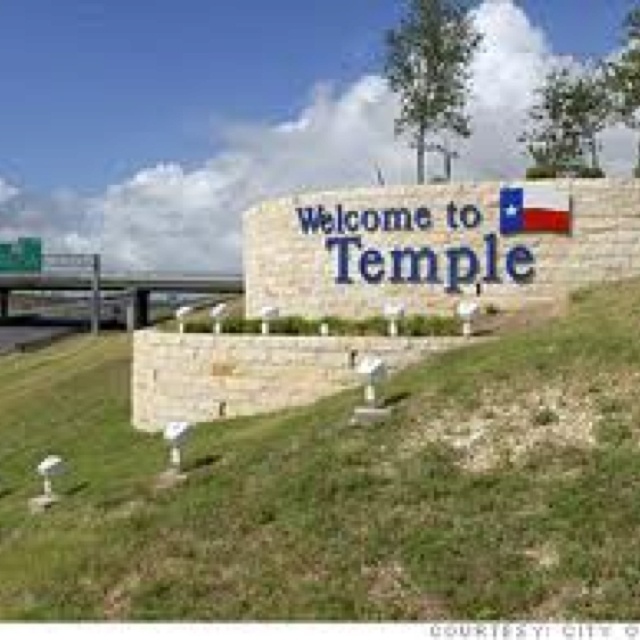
top-left (244, 179), bottom-right (640, 317)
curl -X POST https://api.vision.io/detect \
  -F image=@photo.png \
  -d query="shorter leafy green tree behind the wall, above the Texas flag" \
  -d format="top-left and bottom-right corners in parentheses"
top-left (521, 66), bottom-right (612, 176)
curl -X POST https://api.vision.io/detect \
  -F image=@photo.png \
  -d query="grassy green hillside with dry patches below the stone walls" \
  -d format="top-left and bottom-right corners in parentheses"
top-left (0, 282), bottom-right (640, 620)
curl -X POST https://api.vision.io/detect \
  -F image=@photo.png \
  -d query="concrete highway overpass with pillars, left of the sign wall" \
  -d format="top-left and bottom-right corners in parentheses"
top-left (0, 265), bottom-right (244, 332)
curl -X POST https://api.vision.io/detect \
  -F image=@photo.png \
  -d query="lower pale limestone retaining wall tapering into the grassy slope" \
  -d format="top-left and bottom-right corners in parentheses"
top-left (132, 330), bottom-right (469, 431)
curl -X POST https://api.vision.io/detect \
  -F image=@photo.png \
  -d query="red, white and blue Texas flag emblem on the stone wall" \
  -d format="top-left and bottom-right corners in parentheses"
top-left (500, 185), bottom-right (571, 235)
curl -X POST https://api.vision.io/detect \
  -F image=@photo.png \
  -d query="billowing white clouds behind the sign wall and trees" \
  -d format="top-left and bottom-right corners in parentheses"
top-left (0, 0), bottom-right (634, 271)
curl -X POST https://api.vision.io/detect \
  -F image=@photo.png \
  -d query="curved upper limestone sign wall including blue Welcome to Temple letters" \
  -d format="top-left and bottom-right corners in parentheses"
top-left (244, 180), bottom-right (640, 317)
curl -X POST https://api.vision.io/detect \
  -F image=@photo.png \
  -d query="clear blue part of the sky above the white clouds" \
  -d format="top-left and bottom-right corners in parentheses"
top-left (0, 0), bottom-right (634, 193)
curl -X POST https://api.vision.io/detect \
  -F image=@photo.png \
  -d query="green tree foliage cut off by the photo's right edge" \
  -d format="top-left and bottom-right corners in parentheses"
top-left (609, 7), bottom-right (640, 177)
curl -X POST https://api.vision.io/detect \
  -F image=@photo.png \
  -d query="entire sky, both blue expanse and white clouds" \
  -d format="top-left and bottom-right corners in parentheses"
top-left (0, 0), bottom-right (638, 269)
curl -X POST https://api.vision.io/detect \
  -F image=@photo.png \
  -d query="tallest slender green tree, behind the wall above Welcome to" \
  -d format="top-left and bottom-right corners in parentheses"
top-left (385, 0), bottom-right (481, 184)
